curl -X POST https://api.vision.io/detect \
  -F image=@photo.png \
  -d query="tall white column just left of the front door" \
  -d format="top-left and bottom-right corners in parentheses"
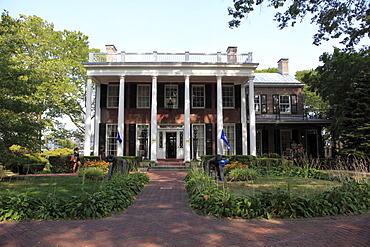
top-left (150, 76), bottom-right (157, 161)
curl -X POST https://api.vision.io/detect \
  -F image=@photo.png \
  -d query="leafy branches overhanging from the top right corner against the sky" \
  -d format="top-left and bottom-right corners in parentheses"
top-left (228, 0), bottom-right (370, 47)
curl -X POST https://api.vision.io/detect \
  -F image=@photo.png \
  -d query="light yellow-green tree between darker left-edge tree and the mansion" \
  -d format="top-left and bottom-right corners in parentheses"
top-left (4, 13), bottom-right (89, 147)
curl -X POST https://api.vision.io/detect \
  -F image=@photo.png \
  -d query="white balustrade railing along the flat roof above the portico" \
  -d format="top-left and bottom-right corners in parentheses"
top-left (89, 52), bottom-right (252, 63)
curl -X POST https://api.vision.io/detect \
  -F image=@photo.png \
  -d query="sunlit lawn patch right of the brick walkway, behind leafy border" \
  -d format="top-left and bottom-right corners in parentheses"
top-left (220, 176), bottom-right (341, 196)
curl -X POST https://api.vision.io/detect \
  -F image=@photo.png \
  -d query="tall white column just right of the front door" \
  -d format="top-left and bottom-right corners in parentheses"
top-left (184, 76), bottom-right (190, 161)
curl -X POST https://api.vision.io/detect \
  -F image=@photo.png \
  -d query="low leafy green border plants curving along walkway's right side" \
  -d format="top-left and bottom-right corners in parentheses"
top-left (185, 165), bottom-right (370, 219)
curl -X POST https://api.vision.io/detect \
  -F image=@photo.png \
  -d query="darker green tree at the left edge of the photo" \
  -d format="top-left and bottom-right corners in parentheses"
top-left (0, 12), bottom-right (45, 158)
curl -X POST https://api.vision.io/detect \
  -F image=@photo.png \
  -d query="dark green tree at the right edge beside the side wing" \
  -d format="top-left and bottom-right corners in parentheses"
top-left (303, 47), bottom-right (370, 154)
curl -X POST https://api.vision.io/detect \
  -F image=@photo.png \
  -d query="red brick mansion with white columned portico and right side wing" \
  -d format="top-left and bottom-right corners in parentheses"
top-left (83, 45), bottom-right (330, 161)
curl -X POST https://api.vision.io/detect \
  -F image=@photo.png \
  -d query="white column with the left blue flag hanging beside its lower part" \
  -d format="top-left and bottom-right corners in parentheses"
top-left (117, 76), bottom-right (125, 156)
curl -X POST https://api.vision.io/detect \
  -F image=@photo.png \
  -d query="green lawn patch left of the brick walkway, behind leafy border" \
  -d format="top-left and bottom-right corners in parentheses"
top-left (0, 176), bottom-right (104, 198)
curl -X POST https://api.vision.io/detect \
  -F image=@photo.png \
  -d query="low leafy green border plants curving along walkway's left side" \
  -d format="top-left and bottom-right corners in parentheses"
top-left (0, 173), bottom-right (149, 221)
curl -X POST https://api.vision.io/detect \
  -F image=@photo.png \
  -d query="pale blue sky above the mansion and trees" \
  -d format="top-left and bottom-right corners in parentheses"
top-left (0, 0), bottom-right (370, 75)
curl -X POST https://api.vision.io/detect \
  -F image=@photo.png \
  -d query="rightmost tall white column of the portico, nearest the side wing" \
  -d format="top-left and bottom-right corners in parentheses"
top-left (249, 78), bottom-right (257, 156)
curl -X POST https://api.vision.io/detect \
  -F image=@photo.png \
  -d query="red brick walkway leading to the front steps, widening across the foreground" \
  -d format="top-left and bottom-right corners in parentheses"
top-left (0, 171), bottom-right (370, 247)
